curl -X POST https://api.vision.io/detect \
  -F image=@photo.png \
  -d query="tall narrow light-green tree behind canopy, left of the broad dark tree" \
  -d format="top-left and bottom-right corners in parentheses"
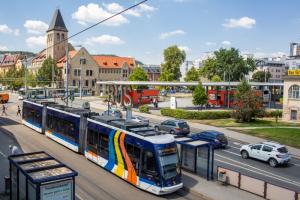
top-left (160, 45), bottom-right (186, 81)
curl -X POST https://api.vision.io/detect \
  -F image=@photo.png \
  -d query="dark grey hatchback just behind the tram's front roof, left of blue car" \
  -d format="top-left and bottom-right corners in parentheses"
top-left (154, 119), bottom-right (190, 136)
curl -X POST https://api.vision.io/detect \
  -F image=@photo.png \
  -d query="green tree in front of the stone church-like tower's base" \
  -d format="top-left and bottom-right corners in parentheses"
top-left (36, 58), bottom-right (61, 86)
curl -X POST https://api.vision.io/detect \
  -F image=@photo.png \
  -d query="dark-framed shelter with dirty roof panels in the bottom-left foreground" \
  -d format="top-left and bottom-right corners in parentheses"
top-left (8, 151), bottom-right (78, 200)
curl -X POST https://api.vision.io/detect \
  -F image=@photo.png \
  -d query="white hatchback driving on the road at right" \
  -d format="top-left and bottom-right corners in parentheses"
top-left (240, 142), bottom-right (291, 167)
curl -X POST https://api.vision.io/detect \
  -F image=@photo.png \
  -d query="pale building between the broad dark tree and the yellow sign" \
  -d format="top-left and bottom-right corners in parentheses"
top-left (254, 58), bottom-right (288, 83)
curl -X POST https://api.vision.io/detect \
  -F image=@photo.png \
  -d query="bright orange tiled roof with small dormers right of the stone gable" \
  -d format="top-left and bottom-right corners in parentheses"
top-left (92, 55), bottom-right (135, 68)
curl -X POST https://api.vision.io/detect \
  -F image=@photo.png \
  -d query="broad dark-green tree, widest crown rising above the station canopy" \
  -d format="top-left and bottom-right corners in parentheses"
top-left (201, 48), bottom-right (256, 81)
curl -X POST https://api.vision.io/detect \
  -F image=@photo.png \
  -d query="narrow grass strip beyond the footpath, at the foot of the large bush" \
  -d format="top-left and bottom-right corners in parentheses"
top-left (193, 118), bottom-right (300, 127)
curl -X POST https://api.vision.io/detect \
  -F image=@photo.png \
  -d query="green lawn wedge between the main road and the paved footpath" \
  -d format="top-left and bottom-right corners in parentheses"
top-left (239, 128), bottom-right (300, 148)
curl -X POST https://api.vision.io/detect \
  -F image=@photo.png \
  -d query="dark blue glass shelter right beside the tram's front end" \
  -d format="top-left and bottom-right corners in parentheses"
top-left (175, 137), bottom-right (214, 180)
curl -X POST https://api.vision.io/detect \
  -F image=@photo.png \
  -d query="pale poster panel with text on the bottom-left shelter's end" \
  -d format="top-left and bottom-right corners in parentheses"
top-left (41, 180), bottom-right (73, 200)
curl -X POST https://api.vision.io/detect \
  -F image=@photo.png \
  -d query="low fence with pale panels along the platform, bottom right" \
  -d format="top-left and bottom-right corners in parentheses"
top-left (217, 166), bottom-right (300, 200)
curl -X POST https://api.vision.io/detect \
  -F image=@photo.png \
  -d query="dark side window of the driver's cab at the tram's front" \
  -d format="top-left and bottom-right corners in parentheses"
top-left (141, 151), bottom-right (159, 182)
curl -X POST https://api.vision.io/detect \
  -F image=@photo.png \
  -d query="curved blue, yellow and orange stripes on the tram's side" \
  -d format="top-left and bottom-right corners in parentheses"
top-left (86, 130), bottom-right (138, 185)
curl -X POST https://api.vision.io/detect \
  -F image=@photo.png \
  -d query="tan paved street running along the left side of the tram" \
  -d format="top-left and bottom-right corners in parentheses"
top-left (0, 96), bottom-right (200, 200)
